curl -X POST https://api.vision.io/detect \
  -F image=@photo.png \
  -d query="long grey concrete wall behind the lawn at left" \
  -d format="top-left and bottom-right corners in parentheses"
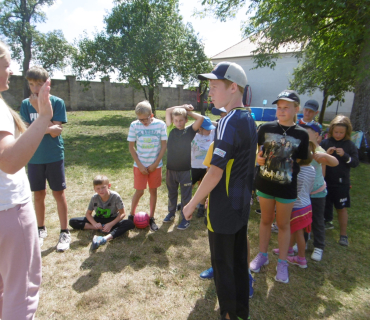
top-left (3, 76), bottom-right (197, 110)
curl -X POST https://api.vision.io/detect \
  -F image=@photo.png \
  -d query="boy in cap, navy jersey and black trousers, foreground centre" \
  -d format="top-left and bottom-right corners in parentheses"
top-left (184, 62), bottom-right (257, 320)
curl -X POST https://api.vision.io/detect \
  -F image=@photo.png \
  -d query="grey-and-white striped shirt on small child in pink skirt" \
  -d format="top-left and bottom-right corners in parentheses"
top-left (294, 166), bottom-right (316, 209)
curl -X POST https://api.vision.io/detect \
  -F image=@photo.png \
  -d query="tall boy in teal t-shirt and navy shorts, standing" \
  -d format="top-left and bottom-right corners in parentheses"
top-left (20, 66), bottom-right (71, 252)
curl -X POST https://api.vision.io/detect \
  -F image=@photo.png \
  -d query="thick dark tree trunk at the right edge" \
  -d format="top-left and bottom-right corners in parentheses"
top-left (351, 24), bottom-right (370, 132)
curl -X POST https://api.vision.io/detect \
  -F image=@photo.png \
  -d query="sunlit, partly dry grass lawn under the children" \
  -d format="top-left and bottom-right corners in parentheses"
top-left (36, 111), bottom-right (370, 320)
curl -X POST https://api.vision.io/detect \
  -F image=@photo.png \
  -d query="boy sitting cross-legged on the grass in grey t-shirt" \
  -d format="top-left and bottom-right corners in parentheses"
top-left (69, 175), bottom-right (135, 250)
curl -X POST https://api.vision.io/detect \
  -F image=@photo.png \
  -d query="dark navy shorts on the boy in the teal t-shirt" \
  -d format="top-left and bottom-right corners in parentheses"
top-left (28, 160), bottom-right (67, 191)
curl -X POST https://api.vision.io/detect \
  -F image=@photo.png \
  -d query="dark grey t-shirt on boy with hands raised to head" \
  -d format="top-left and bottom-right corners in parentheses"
top-left (167, 124), bottom-right (196, 171)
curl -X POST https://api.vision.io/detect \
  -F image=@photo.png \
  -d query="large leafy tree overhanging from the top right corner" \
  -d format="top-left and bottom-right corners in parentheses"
top-left (203, 0), bottom-right (370, 131)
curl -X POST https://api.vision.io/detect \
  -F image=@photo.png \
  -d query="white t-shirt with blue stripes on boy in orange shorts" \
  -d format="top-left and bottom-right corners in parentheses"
top-left (127, 118), bottom-right (167, 168)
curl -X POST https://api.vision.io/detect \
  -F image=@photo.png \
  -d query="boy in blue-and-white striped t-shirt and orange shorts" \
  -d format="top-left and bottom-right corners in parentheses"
top-left (127, 101), bottom-right (167, 231)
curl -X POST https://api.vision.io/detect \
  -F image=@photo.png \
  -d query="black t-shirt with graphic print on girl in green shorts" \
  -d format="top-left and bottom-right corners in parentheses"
top-left (255, 121), bottom-right (309, 199)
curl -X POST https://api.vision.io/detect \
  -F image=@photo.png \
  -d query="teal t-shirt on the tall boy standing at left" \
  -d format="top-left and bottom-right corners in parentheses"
top-left (20, 96), bottom-right (67, 164)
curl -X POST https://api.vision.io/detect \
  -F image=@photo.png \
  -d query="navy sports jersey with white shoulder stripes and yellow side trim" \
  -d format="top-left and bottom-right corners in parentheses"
top-left (207, 108), bottom-right (257, 234)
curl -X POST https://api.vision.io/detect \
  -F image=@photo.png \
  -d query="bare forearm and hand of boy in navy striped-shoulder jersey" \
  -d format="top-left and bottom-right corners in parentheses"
top-left (183, 165), bottom-right (224, 220)
